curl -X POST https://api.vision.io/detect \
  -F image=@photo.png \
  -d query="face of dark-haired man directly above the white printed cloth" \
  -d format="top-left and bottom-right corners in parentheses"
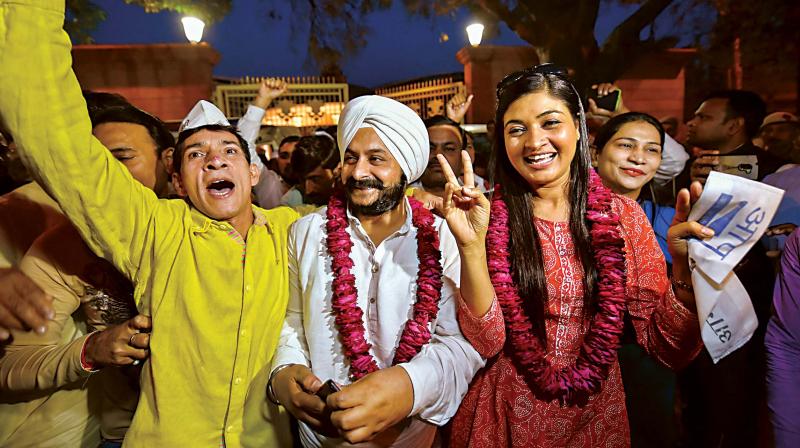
top-left (686, 98), bottom-right (744, 149)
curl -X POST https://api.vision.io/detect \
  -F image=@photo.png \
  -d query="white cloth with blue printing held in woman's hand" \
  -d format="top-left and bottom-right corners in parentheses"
top-left (689, 171), bottom-right (783, 363)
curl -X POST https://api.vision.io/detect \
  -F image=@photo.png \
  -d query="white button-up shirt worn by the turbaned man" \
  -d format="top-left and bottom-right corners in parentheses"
top-left (272, 200), bottom-right (484, 447)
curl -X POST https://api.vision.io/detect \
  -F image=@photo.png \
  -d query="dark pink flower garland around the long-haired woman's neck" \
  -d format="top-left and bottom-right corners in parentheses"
top-left (486, 171), bottom-right (627, 405)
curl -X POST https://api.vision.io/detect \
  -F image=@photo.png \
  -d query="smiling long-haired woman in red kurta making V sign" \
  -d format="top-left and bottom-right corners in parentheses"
top-left (432, 65), bottom-right (711, 448)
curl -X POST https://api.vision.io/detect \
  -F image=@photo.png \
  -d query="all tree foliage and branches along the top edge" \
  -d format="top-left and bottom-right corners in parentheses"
top-left (65, 0), bottom-right (800, 105)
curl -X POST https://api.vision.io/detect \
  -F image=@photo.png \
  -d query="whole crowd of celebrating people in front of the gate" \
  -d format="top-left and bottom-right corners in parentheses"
top-left (0, 0), bottom-right (800, 448)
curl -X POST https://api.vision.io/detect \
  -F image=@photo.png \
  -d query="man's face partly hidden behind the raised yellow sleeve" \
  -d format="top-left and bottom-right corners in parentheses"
top-left (92, 122), bottom-right (171, 196)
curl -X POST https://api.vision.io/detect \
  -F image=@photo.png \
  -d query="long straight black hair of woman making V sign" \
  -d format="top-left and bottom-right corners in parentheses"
top-left (488, 64), bottom-right (596, 343)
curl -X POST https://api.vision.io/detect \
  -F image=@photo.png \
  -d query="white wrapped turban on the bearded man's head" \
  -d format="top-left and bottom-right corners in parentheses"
top-left (337, 95), bottom-right (430, 183)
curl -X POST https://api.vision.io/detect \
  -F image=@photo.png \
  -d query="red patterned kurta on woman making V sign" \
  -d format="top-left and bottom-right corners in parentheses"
top-left (451, 196), bottom-right (701, 448)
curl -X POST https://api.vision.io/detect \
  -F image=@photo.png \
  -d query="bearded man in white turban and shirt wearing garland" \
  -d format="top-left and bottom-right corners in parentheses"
top-left (268, 96), bottom-right (484, 447)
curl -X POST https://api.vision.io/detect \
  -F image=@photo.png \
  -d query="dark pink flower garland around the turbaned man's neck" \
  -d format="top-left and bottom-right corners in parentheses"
top-left (326, 194), bottom-right (442, 380)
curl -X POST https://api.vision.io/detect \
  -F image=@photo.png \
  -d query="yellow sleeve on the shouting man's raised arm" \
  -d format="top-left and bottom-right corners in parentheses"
top-left (0, 0), bottom-right (174, 286)
